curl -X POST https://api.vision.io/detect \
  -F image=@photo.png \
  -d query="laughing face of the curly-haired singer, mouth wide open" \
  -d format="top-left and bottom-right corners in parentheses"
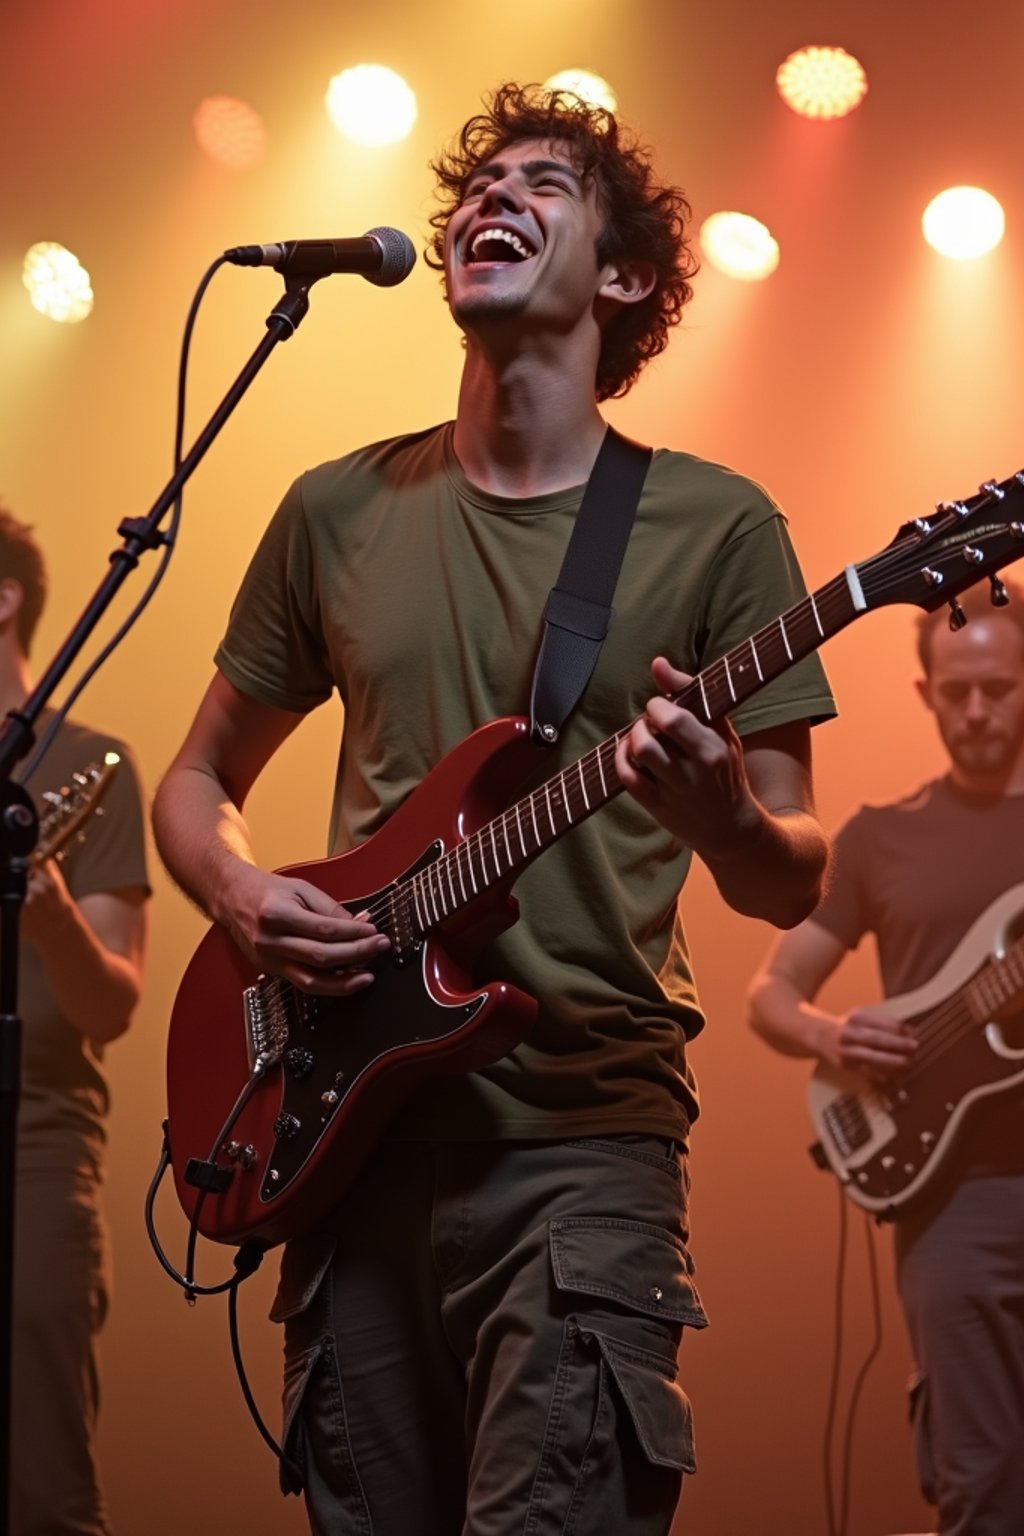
top-left (445, 140), bottom-right (614, 332)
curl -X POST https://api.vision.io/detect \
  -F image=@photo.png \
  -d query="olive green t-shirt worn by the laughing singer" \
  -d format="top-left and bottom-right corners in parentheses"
top-left (216, 425), bottom-right (835, 1140)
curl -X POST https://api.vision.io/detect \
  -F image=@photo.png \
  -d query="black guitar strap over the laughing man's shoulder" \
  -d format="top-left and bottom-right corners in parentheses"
top-left (530, 427), bottom-right (654, 746)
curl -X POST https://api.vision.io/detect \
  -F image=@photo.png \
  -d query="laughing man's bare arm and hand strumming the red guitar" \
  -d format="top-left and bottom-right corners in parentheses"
top-left (154, 673), bottom-right (388, 995)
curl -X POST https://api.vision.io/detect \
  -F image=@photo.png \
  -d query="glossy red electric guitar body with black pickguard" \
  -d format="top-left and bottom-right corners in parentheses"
top-left (167, 719), bottom-right (543, 1246)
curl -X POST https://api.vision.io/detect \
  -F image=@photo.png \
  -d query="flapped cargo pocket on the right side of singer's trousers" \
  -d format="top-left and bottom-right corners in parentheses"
top-left (550, 1217), bottom-right (708, 1473)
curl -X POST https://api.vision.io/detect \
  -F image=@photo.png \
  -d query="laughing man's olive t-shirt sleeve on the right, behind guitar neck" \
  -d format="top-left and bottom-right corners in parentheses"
top-left (697, 506), bottom-right (837, 736)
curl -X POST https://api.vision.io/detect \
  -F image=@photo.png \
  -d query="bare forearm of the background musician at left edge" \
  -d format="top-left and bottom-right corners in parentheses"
top-left (31, 902), bottom-right (141, 1046)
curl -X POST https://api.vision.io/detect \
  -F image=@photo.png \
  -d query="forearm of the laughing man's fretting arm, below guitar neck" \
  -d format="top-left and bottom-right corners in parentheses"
top-left (695, 800), bottom-right (829, 928)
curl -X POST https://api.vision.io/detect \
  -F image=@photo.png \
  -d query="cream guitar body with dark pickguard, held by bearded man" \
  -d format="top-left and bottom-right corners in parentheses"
top-left (808, 885), bottom-right (1024, 1217)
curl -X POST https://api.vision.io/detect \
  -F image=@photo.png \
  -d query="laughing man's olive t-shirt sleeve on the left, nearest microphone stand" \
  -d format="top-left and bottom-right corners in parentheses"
top-left (213, 478), bottom-right (333, 714)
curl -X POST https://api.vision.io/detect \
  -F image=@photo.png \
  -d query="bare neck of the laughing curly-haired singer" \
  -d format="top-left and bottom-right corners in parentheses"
top-left (454, 341), bottom-right (605, 498)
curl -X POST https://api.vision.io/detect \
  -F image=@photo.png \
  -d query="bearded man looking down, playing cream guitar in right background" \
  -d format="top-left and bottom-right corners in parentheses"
top-left (751, 588), bottom-right (1024, 1536)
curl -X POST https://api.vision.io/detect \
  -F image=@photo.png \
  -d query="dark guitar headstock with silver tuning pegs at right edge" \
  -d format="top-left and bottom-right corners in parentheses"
top-left (852, 470), bottom-right (1024, 613)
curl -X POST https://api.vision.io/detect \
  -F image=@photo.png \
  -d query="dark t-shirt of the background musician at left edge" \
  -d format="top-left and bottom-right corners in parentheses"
top-left (18, 716), bottom-right (149, 1174)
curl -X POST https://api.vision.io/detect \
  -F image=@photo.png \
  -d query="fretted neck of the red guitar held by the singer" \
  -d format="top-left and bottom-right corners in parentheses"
top-left (404, 567), bottom-right (866, 932)
